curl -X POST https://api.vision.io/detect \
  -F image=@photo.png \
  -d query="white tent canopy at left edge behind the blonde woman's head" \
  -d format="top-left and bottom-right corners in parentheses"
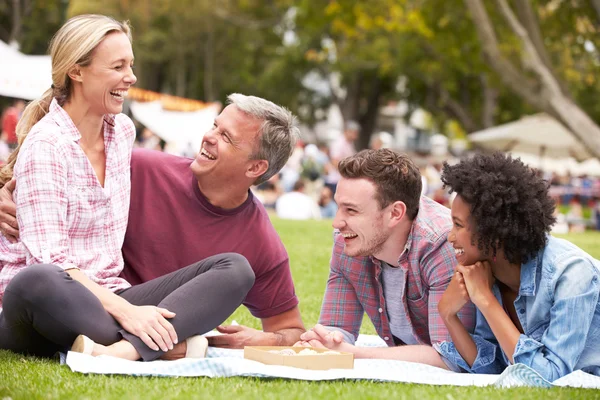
top-left (0, 41), bottom-right (52, 100)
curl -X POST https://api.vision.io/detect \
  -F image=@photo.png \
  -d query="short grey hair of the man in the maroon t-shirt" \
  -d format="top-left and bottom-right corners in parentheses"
top-left (227, 93), bottom-right (300, 185)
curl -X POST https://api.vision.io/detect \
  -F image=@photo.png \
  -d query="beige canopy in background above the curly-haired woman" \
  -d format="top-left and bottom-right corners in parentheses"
top-left (469, 113), bottom-right (592, 161)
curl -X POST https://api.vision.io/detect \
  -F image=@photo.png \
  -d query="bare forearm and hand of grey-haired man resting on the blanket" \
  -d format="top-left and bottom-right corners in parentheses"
top-left (208, 306), bottom-right (305, 349)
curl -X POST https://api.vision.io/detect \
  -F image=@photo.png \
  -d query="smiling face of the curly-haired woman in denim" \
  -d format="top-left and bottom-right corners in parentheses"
top-left (448, 196), bottom-right (487, 265)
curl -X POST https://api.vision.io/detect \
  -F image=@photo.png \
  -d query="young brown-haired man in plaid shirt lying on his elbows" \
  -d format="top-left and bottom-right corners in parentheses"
top-left (301, 149), bottom-right (474, 369)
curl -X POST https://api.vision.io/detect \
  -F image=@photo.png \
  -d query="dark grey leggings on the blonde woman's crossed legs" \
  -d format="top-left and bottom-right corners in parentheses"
top-left (0, 253), bottom-right (254, 361)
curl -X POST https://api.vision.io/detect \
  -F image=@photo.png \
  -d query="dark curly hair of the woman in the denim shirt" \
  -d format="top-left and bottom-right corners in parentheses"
top-left (442, 153), bottom-right (556, 264)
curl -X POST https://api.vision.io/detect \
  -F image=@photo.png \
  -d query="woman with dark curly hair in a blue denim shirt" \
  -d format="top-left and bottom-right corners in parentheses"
top-left (436, 153), bottom-right (600, 381)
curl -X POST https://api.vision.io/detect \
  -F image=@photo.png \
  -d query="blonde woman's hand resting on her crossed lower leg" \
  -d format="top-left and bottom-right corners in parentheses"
top-left (113, 304), bottom-right (177, 352)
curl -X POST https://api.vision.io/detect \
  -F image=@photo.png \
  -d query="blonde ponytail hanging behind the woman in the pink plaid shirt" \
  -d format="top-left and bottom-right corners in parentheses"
top-left (0, 88), bottom-right (54, 188)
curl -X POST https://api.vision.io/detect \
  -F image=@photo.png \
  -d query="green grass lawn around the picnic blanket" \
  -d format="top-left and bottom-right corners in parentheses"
top-left (0, 220), bottom-right (600, 400)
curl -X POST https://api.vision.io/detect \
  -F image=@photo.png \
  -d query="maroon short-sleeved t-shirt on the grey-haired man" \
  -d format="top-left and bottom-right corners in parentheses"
top-left (121, 149), bottom-right (298, 318)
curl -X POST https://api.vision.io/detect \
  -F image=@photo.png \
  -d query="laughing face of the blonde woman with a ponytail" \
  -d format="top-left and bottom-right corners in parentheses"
top-left (77, 32), bottom-right (137, 115)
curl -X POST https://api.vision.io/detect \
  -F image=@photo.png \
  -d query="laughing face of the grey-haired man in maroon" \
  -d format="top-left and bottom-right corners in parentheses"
top-left (191, 104), bottom-right (266, 187)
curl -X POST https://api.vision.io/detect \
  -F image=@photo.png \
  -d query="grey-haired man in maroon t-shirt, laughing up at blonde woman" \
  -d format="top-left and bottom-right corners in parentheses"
top-left (0, 94), bottom-right (304, 348)
